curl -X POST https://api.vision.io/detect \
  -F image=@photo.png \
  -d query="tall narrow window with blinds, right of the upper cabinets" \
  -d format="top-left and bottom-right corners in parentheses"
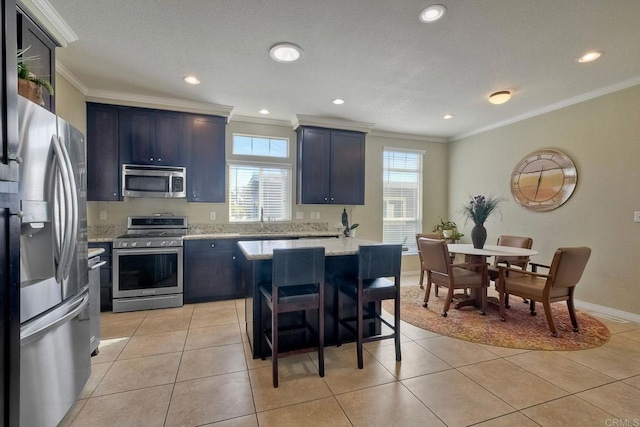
top-left (382, 148), bottom-right (424, 253)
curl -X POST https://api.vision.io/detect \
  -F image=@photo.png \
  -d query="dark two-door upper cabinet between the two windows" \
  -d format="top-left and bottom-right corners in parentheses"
top-left (297, 126), bottom-right (365, 205)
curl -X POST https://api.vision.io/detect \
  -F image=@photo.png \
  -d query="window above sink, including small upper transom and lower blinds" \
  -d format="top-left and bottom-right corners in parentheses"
top-left (229, 135), bottom-right (292, 222)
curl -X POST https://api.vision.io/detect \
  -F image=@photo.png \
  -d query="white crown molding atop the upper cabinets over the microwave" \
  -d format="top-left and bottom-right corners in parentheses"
top-left (86, 89), bottom-right (233, 119)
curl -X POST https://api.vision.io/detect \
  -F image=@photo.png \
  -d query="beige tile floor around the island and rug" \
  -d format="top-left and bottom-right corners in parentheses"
top-left (61, 277), bottom-right (640, 427)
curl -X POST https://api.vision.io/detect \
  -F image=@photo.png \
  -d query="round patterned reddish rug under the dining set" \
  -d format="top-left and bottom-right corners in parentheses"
top-left (383, 286), bottom-right (610, 350)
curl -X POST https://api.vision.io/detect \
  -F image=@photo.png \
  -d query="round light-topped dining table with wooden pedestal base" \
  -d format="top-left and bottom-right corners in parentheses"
top-left (447, 243), bottom-right (539, 309)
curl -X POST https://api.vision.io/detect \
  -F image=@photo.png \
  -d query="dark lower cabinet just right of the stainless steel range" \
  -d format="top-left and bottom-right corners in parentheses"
top-left (184, 239), bottom-right (244, 303)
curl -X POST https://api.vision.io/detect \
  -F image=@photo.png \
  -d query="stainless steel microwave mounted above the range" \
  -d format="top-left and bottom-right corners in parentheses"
top-left (122, 165), bottom-right (187, 198)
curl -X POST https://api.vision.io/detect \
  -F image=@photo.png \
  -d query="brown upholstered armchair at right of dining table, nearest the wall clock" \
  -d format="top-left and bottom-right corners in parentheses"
top-left (496, 246), bottom-right (591, 337)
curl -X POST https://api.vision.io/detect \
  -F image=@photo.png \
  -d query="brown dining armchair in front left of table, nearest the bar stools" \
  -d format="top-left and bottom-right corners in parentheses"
top-left (418, 238), bottom-right (488, 317)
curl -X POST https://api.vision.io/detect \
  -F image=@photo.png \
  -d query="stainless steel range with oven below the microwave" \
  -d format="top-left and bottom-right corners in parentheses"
top-left (113, 216), bottom-right (187, 312)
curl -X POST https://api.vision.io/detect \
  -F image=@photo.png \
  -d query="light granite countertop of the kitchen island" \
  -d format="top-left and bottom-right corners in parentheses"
top-left (238, 237), bottom-right (381, 261)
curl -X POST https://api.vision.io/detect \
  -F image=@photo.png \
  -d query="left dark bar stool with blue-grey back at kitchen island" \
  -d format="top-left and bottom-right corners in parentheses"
top-left (260, 248), bottom-right (324, 387)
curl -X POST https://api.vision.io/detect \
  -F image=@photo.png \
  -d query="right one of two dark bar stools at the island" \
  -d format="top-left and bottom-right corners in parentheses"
top-left (336, 244), bottom-right (402, 369)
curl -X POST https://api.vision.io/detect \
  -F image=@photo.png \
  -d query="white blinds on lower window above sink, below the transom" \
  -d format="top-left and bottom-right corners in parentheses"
top-left (229, 163), bottom-right (291, 222)
